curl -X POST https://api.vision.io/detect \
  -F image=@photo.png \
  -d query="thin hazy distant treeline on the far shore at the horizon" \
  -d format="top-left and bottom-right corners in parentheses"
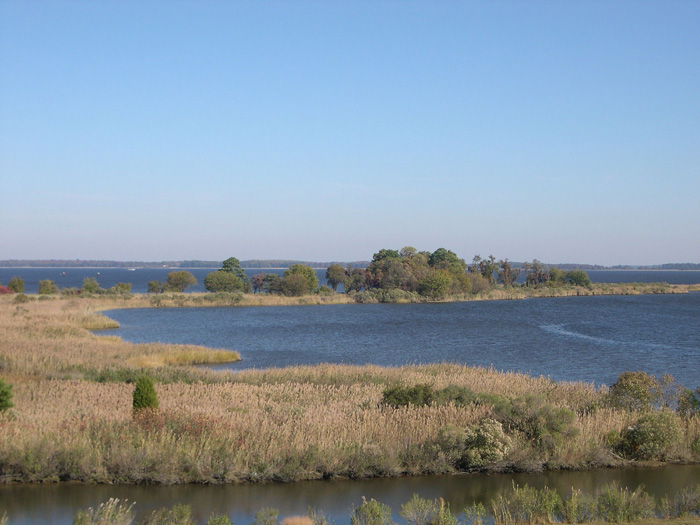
top-left (0, 259), bottom-right (700, 270)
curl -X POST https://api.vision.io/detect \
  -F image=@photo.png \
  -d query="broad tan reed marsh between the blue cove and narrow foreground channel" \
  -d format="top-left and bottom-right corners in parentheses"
top-left (0, 292), bottom-right (700, 484)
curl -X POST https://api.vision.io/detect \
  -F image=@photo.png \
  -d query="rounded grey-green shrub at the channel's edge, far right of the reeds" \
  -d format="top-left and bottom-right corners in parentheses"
top-left (618, 410), bottom-right (683, 459)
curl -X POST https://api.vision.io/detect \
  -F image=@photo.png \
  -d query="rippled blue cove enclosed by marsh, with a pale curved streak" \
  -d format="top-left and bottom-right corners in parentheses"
top-left (106, 292), bottom-right (700, 388)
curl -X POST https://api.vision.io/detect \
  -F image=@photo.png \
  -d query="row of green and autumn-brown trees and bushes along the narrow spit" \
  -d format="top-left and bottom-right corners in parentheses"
top-left (0, 250), bottom-right (591, 302)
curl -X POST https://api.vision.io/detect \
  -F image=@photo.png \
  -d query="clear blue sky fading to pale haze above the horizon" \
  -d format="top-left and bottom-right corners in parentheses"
top-left (0, 0), bottom-right (700, 264)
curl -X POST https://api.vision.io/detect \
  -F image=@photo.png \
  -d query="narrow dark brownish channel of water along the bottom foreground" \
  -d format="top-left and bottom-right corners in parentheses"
top-left (0, 465), bottom-right (700, 525)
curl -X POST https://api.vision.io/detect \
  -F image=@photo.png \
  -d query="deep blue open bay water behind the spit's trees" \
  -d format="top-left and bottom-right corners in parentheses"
top-left (0, 268), bottom-right (700, 293)
